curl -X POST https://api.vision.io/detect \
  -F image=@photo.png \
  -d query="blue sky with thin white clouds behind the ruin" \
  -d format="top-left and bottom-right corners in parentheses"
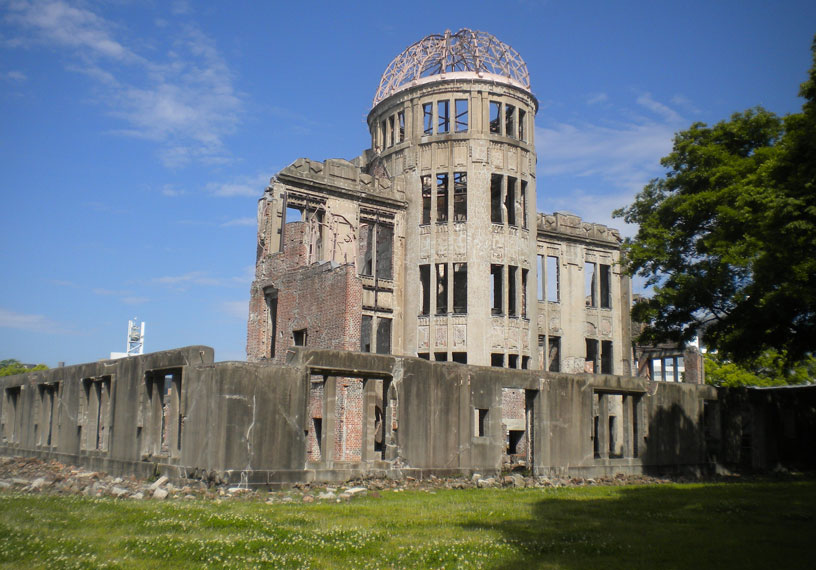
top-left (0, 0), bottom-right (816, 366)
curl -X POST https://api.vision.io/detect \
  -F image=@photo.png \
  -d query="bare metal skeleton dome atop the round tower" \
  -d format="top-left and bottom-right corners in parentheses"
top-left (372, 28), bottom-right (530, 106)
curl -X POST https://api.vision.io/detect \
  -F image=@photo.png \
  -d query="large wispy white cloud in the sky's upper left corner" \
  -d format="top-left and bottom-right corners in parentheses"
top-left (5, 0), bottom-right (242, 166)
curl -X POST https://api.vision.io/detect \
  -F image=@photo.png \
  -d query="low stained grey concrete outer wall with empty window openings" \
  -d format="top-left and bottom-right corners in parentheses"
top-left (0, 346), bottom-right (776, 485)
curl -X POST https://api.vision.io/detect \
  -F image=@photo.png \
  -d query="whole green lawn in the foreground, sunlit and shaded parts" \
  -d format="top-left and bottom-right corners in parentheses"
top-left (0, 481), bottom-right (816, 570)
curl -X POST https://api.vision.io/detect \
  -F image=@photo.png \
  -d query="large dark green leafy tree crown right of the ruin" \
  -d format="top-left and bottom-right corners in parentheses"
top-left (615, 38), bottom-right (816, 362)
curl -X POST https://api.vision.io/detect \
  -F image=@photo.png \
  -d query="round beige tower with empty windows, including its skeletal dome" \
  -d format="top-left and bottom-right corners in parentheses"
top-left (368, 29), bottom-right (538, 368)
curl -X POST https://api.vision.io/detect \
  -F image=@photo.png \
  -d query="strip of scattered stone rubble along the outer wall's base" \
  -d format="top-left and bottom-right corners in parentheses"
top-left (0, 457), bottom-right (740, 504)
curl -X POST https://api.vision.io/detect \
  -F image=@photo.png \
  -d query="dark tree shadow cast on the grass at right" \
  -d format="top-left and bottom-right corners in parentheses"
top-left (464, 481), bottom-right (816, 570)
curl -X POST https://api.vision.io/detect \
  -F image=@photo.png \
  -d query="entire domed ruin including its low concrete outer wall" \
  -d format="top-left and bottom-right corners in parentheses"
top-left (6, 30), bottom-right (816, 485)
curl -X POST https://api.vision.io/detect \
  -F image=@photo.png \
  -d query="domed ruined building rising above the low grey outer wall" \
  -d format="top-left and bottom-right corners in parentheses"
top-left (247, 29), bottom-right (632, 375)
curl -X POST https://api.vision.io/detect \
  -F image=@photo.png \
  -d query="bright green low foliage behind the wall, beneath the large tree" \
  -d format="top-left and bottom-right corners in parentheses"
top-left (705, 350), bottom-right (816, 388)
